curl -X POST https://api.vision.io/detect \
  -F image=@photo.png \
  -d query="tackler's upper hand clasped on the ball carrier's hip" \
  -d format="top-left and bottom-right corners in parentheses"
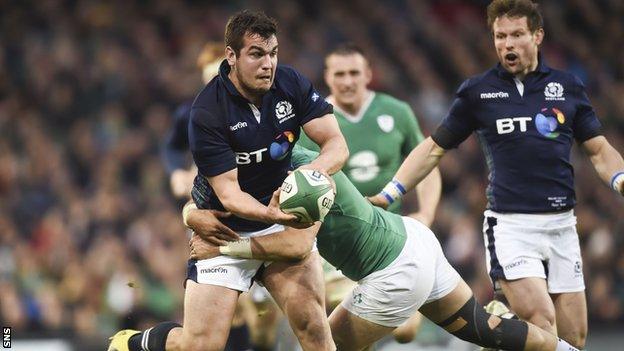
top-left (186, 209), bottom-right (240, 246)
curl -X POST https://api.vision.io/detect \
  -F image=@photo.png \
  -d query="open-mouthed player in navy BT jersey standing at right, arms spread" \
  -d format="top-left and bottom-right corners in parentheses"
top-left (371, 0), bottom-right (624, 348)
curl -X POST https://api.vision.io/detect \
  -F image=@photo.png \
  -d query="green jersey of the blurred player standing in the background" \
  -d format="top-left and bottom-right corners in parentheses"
top-left (298, 92), bottom-right (424, 213)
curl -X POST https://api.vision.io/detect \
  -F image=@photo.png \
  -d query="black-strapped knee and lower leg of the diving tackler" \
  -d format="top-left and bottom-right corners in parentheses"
top-left (438, 297), bottom-right (528, 351)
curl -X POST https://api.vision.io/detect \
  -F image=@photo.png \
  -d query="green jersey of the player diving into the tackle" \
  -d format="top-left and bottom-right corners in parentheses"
top-left (292, 145), bottom-right (407, 281)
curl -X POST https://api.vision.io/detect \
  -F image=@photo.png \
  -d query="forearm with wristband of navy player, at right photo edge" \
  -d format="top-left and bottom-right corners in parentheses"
top-left (581, 135), bottom-right (624, 195)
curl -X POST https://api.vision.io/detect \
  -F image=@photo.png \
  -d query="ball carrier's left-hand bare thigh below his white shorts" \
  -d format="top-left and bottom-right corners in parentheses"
top-left (182, 280), bottom-right (239, 350)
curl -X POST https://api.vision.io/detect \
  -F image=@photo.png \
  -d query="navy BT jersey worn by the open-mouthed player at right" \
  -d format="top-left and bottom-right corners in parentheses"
top-left (433, 57), bottom-right (600, 213)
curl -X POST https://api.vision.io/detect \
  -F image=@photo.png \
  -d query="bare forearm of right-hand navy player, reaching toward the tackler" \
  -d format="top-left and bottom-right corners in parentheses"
top-left (394, 137), bottom-right (445, 192)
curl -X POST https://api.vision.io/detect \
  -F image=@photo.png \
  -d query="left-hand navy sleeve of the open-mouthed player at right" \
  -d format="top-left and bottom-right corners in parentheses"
top-left (431, 80), bottom-right (477, 150)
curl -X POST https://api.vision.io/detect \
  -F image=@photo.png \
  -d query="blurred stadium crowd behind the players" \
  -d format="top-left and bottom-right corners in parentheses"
top-left (0, 0), bottom-right (624, 348)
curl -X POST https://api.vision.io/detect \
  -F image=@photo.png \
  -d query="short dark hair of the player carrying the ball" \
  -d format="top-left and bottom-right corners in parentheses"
top-left (225, 10), bottom-right (277, 55)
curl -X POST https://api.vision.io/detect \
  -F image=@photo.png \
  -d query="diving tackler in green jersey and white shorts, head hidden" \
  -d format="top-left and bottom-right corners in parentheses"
top-left (186, 146), bottom-right (577, 351)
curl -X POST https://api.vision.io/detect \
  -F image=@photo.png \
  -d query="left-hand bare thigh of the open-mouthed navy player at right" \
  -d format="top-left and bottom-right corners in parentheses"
top-left (498, 278), bottom-right (556, 333)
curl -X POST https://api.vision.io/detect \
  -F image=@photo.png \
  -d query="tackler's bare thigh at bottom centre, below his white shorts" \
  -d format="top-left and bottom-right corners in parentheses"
top-left (329, 305), bottom-right (395, 351)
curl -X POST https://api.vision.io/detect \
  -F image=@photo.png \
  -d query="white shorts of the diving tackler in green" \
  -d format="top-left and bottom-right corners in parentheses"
top-left (341, 217), bottom-right (461, 327)
